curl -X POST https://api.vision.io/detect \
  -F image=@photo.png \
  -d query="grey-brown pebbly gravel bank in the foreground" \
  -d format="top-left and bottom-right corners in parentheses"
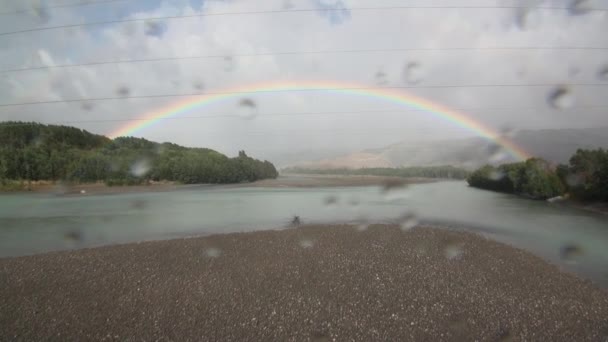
top-left (0, 226), bottom-right (608, 341)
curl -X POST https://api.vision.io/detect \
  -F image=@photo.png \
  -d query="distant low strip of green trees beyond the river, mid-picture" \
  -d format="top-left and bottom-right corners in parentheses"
top-left (283, 166), bottom-right (470, 179)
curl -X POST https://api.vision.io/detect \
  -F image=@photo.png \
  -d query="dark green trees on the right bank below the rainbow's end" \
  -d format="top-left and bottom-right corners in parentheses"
top-left (467, 149), bottom-right (608, 201)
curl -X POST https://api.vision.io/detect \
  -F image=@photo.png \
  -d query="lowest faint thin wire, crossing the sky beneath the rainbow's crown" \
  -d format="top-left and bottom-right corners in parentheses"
top-left (0, 105), bottom-right (608, 127)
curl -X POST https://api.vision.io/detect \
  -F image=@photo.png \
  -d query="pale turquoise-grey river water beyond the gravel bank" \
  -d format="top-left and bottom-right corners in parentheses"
top-left (0, 181), bottom-right (608, 287)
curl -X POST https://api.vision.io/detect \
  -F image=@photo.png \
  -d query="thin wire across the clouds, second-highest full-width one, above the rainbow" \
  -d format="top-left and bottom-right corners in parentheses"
top-left (0, 46), bottom-right (608, 73)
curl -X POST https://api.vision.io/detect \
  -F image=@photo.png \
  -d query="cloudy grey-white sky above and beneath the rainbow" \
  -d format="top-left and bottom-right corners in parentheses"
top-left (0, 0), bottom-right (608, 163)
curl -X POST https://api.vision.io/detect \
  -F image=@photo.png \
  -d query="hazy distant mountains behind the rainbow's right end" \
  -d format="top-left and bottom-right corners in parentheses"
top-left (293, 127), bottom-right (608, 168)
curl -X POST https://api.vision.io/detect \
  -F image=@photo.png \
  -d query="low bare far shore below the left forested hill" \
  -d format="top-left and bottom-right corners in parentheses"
top-left (0, 175), bottom-right (437, 195)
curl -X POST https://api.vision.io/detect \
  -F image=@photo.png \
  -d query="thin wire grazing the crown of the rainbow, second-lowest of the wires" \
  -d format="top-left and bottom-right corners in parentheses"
top-left (0, 83), bottom-right (608, 107)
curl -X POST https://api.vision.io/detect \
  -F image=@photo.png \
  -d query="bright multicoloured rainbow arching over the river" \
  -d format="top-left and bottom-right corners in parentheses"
top-left (110, 81), bottom-right (530, 160)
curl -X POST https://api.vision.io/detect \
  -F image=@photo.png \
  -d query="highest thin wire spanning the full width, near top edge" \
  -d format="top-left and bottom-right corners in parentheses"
top-left (0, 6), bottom-right (608, 36)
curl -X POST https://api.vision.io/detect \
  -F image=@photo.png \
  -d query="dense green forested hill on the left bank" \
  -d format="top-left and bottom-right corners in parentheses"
top-left (0, 122), bottom-right (278, 189)
